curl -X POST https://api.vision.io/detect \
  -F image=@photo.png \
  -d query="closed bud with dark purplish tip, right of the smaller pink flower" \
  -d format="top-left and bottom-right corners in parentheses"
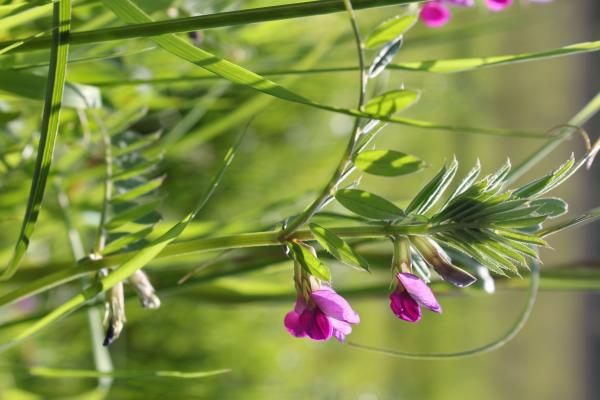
top-left (410, 236), bottom-right (477, 288)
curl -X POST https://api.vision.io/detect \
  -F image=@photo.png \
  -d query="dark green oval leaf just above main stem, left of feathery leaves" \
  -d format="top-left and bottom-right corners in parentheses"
top-left (335, 189), bottom-right (404, 220)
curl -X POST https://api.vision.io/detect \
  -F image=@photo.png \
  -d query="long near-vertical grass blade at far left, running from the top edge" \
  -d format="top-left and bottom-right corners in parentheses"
top-left (0, 0), bottom-right (71, 280)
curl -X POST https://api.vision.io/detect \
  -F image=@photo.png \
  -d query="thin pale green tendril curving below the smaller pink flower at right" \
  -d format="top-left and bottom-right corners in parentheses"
top-left (346, 262), bottom-right (540, 360)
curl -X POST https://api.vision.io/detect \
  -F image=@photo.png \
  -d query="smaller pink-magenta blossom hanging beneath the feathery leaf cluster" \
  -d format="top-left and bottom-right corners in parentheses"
top-left (390, 272), bottom-right (442, 322)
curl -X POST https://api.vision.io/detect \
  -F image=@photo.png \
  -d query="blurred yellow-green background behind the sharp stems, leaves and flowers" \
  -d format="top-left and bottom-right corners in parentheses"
top-left (0, 0), bottom-right (600, 400)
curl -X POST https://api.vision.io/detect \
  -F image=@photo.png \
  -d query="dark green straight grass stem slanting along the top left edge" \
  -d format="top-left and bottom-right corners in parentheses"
top-left (0, 0), bottom-right (414, 53)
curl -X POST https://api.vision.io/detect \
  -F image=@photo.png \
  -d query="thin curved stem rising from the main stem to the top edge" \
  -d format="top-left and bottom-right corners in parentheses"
top-left (280, 0), bottom-right (367, 239)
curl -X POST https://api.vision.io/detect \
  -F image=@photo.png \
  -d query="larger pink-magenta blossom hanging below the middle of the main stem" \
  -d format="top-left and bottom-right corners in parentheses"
top-left (284, 286), bottom-right (360, 342)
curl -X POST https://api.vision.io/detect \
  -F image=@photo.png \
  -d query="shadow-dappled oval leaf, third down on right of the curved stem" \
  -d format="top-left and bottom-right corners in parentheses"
top-left (354, 150), bottom-right (425, 176)
